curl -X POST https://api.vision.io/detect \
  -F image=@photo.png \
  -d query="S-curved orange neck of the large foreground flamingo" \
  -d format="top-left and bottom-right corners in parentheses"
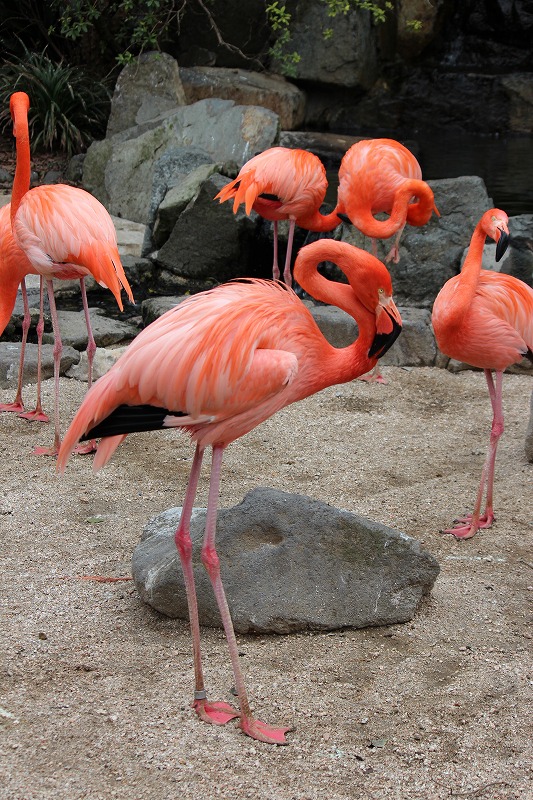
top-left (294, 239), bottom-right (377, 385)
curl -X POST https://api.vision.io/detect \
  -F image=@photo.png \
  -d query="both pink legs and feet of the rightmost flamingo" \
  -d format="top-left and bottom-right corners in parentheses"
top-left (442, 369), bottom-right (504, 539)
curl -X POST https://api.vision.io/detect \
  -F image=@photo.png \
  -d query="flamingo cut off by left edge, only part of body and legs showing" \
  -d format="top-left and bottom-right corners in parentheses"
top-left (0, 202), bottom-right (48, 422)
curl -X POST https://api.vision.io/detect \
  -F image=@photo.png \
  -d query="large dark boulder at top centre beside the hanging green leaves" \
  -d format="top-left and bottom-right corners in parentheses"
top-left (275, 0), bottom-right (378, 89)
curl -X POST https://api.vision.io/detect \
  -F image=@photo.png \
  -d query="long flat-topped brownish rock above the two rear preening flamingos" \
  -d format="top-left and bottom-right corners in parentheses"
top-left (180, 67), bottom-right (305, 130)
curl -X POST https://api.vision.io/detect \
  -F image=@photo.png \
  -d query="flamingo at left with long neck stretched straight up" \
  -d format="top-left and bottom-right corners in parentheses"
top-left (10, 92), bottom-right (133, 455)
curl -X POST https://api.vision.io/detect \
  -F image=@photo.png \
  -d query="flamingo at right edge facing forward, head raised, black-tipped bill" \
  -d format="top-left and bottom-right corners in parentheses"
top-left (432, 208), bottom-right (533, 539)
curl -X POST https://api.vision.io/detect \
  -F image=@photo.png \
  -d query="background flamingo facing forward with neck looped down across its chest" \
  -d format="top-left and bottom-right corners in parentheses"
top-left (337, 139), bottom-right (439, 264)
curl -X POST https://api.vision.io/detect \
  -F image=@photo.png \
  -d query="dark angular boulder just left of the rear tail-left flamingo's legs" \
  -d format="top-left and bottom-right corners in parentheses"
top-left (156, 175), bottom-right (258, 288)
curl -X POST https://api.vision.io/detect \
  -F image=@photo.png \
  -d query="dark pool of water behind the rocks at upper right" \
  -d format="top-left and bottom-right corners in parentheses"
top-left (418, 134), bottom-right (533, 217)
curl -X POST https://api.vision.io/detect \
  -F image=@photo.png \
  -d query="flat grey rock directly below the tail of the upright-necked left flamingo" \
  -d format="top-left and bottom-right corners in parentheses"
top-left (43, 308), bottom-right (139, 350)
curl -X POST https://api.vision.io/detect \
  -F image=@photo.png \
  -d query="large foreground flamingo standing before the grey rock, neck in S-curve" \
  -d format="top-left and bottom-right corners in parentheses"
top-left (57, 240), bottom-right (401, 744)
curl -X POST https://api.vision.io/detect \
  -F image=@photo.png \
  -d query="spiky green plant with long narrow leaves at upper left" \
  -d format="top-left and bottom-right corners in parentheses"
top-left (0, 48), bottom-right (110, 156)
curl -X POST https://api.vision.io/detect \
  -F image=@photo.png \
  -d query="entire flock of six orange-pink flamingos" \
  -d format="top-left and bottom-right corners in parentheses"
top-left (0, 92), bottom-right (533, 745)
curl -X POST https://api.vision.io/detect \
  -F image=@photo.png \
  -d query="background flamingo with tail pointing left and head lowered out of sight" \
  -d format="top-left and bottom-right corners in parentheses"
top-left (215, 147), bottom-right (341, 286)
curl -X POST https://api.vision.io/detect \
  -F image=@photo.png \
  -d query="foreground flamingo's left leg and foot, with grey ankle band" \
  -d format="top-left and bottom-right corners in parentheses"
top-left (175, 447), bottom-right (239, 725)
